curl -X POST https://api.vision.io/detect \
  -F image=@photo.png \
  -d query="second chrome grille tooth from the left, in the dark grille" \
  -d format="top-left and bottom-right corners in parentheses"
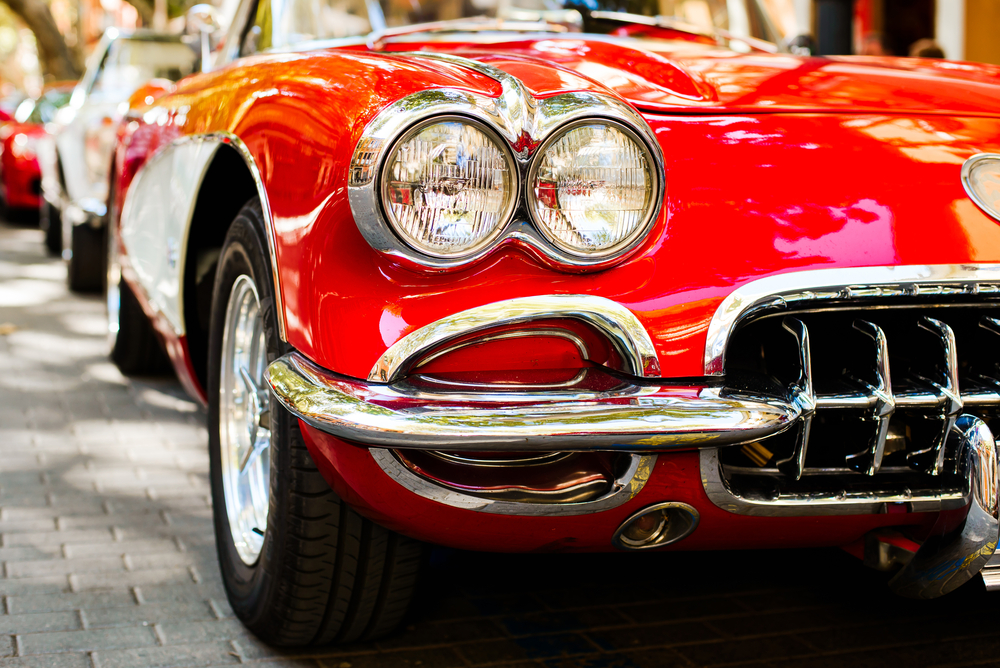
top-left (845, 320), bottom-right (896, 475)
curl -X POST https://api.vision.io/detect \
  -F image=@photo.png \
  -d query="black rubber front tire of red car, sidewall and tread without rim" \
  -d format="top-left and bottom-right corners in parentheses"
top-left (208, 198), bottom-right (422, 646)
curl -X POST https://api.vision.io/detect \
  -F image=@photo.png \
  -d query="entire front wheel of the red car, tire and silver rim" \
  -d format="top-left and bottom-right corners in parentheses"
top-left (208, 199), bottom-right (421, 646)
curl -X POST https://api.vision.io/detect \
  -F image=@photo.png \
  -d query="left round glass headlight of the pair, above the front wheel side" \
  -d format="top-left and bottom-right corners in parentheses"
top-left (382, 118), bottom-right (517, 258)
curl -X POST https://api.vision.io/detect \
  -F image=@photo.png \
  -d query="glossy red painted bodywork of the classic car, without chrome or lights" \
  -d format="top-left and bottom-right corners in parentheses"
top-left (114, 26), bottom-right (1000, 588)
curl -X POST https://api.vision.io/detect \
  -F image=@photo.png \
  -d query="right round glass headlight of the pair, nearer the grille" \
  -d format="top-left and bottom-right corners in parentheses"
top-left (529, 120), bottom-right (659, 257)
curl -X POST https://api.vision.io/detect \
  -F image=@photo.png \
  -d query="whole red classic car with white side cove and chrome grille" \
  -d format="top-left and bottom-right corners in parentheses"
top-left (108, 0), bottom-right (1000, 645)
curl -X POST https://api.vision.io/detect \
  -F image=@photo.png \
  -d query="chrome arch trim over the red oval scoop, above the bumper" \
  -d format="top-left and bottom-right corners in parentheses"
top-left (368, 295), bottom-right (660, 383)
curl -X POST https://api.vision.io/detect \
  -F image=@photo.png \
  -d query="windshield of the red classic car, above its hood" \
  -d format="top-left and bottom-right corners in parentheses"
top-left (243, 0), bottom-right (792, 55)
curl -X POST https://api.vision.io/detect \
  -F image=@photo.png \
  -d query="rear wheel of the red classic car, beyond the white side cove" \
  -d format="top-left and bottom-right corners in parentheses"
top-left (109, 222), bottom-right (173, 376)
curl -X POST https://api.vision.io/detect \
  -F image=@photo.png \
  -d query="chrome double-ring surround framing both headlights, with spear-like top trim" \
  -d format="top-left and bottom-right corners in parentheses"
top-left (347, 52), bottom-right (666, 271)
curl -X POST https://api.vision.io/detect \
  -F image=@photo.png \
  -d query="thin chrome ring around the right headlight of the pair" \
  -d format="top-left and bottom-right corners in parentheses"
top-left (524, 116), bottom-right (664, 260)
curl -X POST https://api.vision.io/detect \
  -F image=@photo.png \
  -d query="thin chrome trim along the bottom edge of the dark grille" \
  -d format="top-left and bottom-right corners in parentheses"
top-left (699, 448), bottom-right (966, 517)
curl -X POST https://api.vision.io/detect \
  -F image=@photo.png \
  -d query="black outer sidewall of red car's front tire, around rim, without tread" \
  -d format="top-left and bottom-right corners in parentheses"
top-left (208, 200), bottom-right (297, 629)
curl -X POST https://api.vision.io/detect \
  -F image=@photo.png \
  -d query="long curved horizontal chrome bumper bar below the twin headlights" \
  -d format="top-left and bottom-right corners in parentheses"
top-left (267, 353), bottom-right (800, 452)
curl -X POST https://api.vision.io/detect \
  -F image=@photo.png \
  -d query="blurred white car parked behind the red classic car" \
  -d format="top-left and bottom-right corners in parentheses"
top-left (39, 28), bottom-right (199, 291)
